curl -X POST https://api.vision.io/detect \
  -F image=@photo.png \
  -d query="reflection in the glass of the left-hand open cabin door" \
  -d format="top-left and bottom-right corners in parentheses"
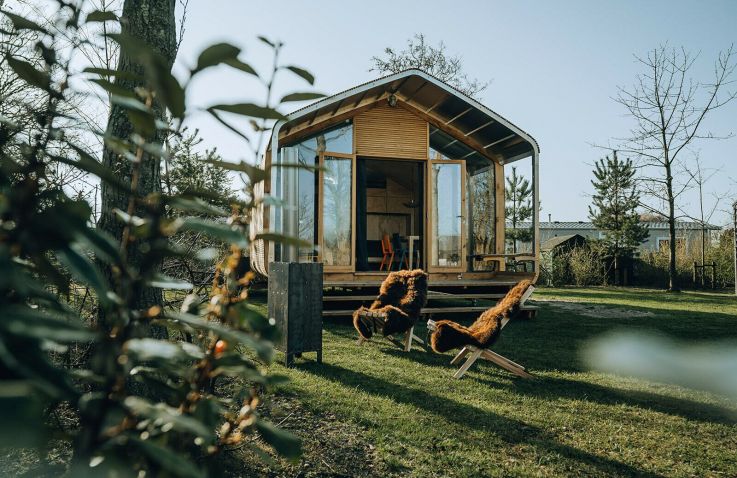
top-left (322, 156), bottom-right (353, 266)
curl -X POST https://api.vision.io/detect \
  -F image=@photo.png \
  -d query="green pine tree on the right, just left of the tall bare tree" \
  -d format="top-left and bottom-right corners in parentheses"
top-left (589, 151), bottom-right (648, 283)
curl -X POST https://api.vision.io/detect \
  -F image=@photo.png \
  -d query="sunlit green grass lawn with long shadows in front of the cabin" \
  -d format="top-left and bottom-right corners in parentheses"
top-left (237, 288), bottom-right (737, 476)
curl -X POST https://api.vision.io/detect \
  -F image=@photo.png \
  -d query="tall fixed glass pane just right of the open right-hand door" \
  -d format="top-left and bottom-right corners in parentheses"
top-left (468, 166), bottom-right (496, 271)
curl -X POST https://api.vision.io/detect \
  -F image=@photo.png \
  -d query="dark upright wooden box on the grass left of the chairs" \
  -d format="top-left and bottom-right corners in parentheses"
top-left (269, 262), bottom-right (322, 367)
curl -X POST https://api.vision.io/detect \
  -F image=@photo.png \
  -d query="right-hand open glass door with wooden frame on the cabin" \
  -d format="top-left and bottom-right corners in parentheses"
top-left (428, 160), bottom-right (466, 272)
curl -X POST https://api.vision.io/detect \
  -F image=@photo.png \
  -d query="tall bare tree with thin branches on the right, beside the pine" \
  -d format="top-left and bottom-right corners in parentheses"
top-left (615, 45), bottom-right (737, 291)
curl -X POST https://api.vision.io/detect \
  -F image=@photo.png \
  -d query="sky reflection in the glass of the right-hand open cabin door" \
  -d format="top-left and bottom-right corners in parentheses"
top-left (431, 163), bottom-right (463, 267)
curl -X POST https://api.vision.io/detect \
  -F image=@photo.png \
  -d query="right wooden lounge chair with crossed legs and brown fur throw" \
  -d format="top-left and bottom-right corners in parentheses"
top-left (427, 280), bottom-right (535, 378)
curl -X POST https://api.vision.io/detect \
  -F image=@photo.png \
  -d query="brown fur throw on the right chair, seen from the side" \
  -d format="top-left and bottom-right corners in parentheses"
top-left (430, 280), bottom-right (532, 353)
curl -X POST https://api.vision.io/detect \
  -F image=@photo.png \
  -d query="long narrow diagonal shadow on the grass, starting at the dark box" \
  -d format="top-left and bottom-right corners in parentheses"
top-left (300, 363), bottom-right (662, 477)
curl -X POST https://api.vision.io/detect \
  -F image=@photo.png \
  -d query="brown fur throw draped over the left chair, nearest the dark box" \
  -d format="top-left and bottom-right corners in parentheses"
top-left (353, 269), bottom-right (427, 339)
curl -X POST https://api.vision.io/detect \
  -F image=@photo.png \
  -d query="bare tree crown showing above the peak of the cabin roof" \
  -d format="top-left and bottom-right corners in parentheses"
top-left (369, 33), bottom-right (489, 99)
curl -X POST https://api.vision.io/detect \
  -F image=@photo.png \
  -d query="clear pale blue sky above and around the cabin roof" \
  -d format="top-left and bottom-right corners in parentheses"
top-left (178, 0), bottom-right (737, 224)
